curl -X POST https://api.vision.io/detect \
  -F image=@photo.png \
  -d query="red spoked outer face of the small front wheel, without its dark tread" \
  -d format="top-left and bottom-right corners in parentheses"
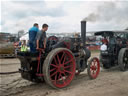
top-left (90, 58), bottom-right (100, 78)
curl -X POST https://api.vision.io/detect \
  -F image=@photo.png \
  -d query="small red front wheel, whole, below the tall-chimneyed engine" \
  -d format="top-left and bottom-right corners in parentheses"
top-left (87, 57), bottom-right (100, 79)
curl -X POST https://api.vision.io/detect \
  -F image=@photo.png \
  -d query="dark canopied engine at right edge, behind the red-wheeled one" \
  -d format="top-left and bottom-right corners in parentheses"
top-left (95, 30), bottom-right (128, 71)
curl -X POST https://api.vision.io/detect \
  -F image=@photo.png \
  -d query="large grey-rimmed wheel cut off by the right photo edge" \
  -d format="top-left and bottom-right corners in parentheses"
top-left (118, 48), bottom-right (128, 71)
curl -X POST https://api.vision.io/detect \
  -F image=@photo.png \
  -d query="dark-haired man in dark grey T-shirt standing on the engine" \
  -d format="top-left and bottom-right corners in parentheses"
top-left (36, 24), bottom-right (48, 52)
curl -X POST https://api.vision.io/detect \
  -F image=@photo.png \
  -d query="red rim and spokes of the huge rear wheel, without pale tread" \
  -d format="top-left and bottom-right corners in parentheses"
top-left (49, 50), bottom-right (76, 88)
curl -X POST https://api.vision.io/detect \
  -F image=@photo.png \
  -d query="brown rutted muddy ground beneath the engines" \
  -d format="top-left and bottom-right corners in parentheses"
top-left (0, 53), bottom-right (128, 96)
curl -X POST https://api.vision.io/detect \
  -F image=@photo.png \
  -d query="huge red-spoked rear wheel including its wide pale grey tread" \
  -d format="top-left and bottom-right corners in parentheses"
top-left (43, 48), bottom-right (76, 88)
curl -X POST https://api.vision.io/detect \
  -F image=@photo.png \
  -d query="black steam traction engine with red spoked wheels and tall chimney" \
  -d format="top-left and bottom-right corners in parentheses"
top-left (18, 21), bottom-right (100, 88)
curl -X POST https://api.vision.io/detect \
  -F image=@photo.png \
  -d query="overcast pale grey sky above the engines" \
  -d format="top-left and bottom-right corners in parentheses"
top-left (0, 0), bottom-right (128, 33)
